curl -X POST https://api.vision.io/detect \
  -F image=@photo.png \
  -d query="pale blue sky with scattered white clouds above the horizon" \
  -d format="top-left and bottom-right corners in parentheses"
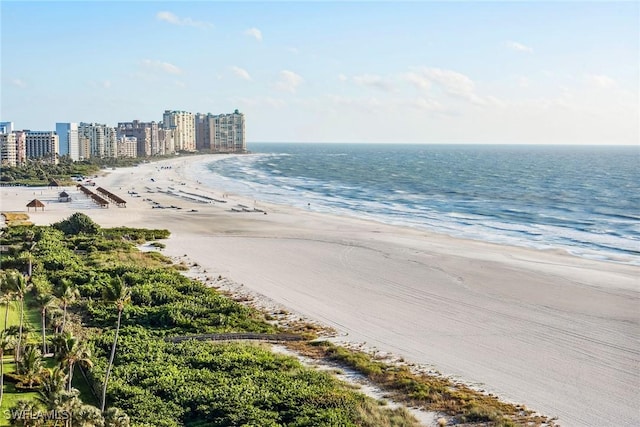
top-left (0, 0), bottom-right (640, 144)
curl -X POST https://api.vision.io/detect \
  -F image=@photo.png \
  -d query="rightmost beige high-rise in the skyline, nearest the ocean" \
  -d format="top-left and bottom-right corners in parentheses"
top-left (196, 110), bottom-right (247, 153)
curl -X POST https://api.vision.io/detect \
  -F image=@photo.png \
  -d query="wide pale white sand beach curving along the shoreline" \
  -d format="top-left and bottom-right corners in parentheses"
top-left (0, 156), bottom-right (640, 426)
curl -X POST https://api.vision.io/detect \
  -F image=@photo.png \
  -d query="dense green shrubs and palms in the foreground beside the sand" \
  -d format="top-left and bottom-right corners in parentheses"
top-left (0, 214), bottom-right (415, 426)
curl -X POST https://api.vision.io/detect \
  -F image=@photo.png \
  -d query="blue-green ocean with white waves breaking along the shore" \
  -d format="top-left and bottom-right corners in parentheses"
top-left (192, 143), bottom-right (640, 265)
